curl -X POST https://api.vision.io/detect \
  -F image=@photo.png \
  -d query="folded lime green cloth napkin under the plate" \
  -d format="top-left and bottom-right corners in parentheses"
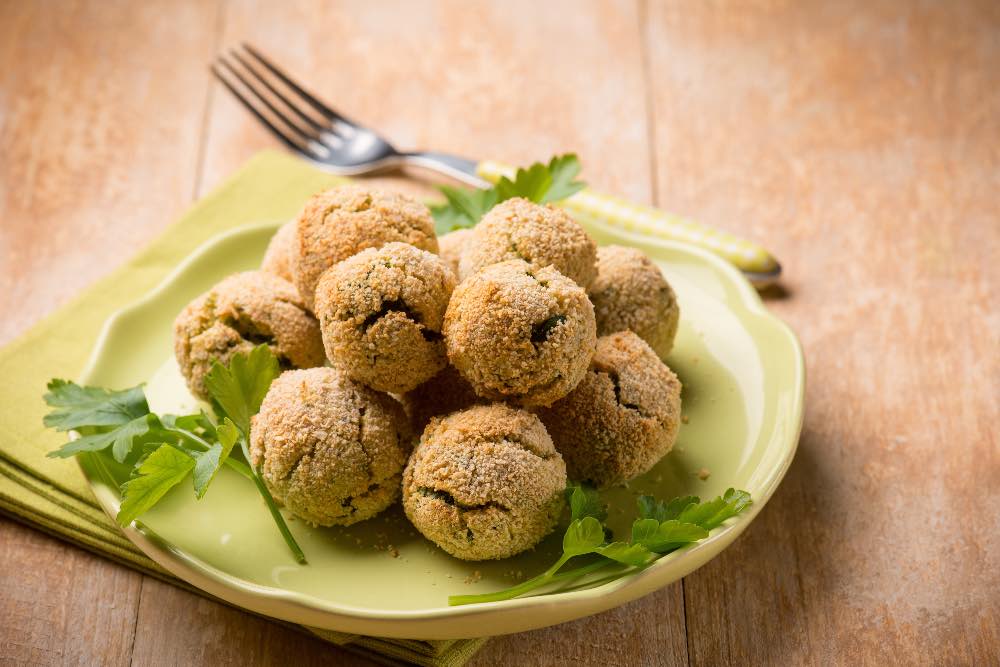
top-left (0, 151), bottom-right (486, 667)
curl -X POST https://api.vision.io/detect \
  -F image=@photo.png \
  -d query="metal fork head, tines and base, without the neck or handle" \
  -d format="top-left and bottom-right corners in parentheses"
top-left (212, 44), bottom-right (403, 175)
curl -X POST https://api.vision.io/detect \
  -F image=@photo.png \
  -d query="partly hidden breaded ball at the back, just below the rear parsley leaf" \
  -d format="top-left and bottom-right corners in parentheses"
top-left (458, 197), bottom-right (597, 288)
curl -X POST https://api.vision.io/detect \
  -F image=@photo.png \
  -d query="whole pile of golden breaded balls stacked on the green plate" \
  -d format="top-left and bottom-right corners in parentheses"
top-left (174, 186), bottom-right (681, 560)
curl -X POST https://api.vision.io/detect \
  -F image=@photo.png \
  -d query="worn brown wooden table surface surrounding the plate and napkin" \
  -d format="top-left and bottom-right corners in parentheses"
top-left (0, 0), bottom-right (1000, 665)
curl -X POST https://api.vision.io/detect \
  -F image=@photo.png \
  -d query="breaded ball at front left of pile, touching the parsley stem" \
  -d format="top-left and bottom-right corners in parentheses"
top-left (250, 368), bottom-right (412, 526)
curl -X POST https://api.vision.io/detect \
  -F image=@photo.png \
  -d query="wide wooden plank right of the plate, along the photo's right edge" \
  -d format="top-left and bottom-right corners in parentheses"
top-left (647, 1), bottom-right (1000, 665)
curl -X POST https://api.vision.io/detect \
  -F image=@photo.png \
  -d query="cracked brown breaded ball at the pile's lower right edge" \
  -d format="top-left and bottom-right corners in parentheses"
top-left (538, 331), bottom-right (681, 488)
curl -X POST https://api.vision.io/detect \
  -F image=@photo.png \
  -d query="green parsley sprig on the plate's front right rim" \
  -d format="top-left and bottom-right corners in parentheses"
top-left (448, 486), bottom-right (752, 605)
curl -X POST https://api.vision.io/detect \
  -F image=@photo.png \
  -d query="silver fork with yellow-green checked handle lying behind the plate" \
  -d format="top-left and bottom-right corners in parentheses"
top-left (211, 44), bottom-right (781, 287)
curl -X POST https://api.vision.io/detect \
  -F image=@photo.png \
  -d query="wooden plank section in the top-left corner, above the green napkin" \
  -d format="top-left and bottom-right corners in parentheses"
top-left (0, 0), bottom-right (217, 343)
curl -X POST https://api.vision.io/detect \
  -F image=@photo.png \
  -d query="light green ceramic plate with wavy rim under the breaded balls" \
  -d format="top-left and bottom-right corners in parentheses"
top-left (81, 222), bottom-right (804, 639)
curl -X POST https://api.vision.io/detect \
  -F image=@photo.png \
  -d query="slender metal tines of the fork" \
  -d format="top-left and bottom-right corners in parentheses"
top-left (212, 44), bottom-right (355, 160)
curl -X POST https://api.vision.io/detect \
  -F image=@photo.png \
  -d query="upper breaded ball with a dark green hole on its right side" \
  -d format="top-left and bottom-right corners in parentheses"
top-left (444, 259), bottom-right (597, 406)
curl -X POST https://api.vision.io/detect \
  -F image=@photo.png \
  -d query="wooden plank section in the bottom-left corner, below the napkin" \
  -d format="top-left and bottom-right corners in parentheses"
top-left (0, 518), bottom-right (142, 665)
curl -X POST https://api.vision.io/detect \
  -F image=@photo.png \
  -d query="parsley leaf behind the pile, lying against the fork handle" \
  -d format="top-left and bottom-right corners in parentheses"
top-left (431, 153), bottom-right (586, 234)
